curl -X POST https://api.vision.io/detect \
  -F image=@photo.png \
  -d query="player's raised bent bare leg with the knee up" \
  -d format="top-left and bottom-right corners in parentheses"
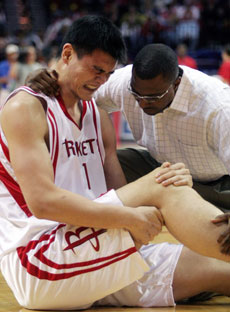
top-left (116, 168), bottom-right (230, 261)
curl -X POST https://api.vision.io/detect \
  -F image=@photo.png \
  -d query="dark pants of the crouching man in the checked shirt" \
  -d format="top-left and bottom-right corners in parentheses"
top-left (117, 148), bottom-right (230, 211)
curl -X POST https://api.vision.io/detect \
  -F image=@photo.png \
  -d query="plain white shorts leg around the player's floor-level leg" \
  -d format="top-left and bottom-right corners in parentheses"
top-left (95, 243), bottom-right (183, 307)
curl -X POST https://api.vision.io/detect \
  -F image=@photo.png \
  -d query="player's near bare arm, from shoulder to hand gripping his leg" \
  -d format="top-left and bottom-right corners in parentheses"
top-left (1, 92), bottom-right (160, 243)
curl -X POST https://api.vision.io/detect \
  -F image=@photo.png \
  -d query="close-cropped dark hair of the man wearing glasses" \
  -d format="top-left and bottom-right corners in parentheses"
top-left (133, 44), bottom-right (179, 82)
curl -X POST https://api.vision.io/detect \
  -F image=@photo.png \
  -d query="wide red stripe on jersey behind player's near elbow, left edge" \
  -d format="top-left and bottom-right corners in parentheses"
top-left (0, 162), bottom-right (32, 217)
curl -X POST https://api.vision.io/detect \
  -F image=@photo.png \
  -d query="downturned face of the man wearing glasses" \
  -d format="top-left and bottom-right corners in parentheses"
top-left (129, 71), bottom-right (181, 115)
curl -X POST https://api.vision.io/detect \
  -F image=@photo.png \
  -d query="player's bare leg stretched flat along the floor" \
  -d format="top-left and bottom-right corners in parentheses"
top-left (173, 247), bottom-right (230, 301)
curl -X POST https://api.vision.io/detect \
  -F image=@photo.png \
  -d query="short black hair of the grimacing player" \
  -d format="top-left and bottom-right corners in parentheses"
top-left (58, 15), bottom-right (126, 63)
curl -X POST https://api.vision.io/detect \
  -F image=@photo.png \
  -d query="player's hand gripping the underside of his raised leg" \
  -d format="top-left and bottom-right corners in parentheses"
top-left (128, 206), bottom-right (164, 247)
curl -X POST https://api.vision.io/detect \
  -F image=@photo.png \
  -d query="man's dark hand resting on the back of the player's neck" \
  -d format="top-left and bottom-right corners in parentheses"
top-left (25, 68), bottom-right (60, 97)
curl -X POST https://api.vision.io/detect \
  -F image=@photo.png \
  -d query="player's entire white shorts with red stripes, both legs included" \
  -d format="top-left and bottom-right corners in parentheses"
top-left (1, 190), bottom-right (183, 310)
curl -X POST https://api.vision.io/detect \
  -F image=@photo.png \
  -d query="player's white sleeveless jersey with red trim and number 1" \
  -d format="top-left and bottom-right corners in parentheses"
top-left (0, 87), bottom-right (107, 258)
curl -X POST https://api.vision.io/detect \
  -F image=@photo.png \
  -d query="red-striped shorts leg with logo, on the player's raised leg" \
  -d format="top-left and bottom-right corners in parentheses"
top-left (1, 190), bottom-right (149, 310)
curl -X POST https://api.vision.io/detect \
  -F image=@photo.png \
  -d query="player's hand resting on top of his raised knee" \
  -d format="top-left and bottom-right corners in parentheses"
top-left (156, 162), bottom-right (193, 187)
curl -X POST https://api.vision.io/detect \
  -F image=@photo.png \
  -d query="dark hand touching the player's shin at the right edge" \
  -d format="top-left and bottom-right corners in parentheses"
top-left (212, 212), bottom-right (230, 255)
